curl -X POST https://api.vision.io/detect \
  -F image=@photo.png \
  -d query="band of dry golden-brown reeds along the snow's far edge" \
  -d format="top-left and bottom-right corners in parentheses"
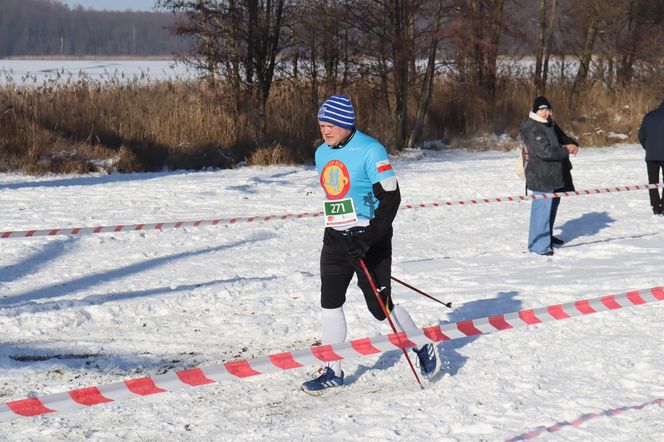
top-left (0, 71), bottom-right (661, 174)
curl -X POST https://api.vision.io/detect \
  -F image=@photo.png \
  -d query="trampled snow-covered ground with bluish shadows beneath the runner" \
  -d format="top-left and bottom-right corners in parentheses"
top-left (0, 145), bottom-right (664, 442)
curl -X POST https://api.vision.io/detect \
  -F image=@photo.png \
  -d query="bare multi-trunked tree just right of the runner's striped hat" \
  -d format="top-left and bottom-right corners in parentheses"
top-left (352, 0), bottom-right (452, 149)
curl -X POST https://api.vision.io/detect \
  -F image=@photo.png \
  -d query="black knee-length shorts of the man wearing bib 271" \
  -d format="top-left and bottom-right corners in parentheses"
top-left (320, 228), bottom-right (392, 321)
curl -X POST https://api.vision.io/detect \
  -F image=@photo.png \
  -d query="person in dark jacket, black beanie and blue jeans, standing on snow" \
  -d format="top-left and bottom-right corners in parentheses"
top-left (520, 97), bottom-right (579, 256)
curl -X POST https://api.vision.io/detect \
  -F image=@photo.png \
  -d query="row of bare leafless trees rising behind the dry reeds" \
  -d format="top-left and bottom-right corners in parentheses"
top-left (158, 0), bottom-right (664, 149)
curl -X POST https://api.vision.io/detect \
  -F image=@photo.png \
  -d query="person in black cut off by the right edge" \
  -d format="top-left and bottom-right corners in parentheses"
top-left (639, 102), bottom-right (664, 215)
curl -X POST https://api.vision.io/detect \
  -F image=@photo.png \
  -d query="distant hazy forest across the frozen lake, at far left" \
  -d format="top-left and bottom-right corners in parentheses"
top-left (0, 0), bottom-right (188, 58)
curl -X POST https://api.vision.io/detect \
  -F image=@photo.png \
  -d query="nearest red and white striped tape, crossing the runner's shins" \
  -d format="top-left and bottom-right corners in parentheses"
top-left (0, 287), bottom-right (664, 422)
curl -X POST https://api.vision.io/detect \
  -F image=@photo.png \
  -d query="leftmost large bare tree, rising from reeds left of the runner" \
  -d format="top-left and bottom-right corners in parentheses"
top-left (157, 0), bottom-right (287, 132)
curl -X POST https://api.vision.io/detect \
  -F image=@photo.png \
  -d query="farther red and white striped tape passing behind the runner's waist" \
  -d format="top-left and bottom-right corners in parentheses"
top-left (0, 184), bottom-right (664, 239)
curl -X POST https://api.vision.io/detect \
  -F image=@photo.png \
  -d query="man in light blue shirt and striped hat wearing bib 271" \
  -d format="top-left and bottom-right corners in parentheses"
top-left (302, 95), bottom-right (436, 395)
